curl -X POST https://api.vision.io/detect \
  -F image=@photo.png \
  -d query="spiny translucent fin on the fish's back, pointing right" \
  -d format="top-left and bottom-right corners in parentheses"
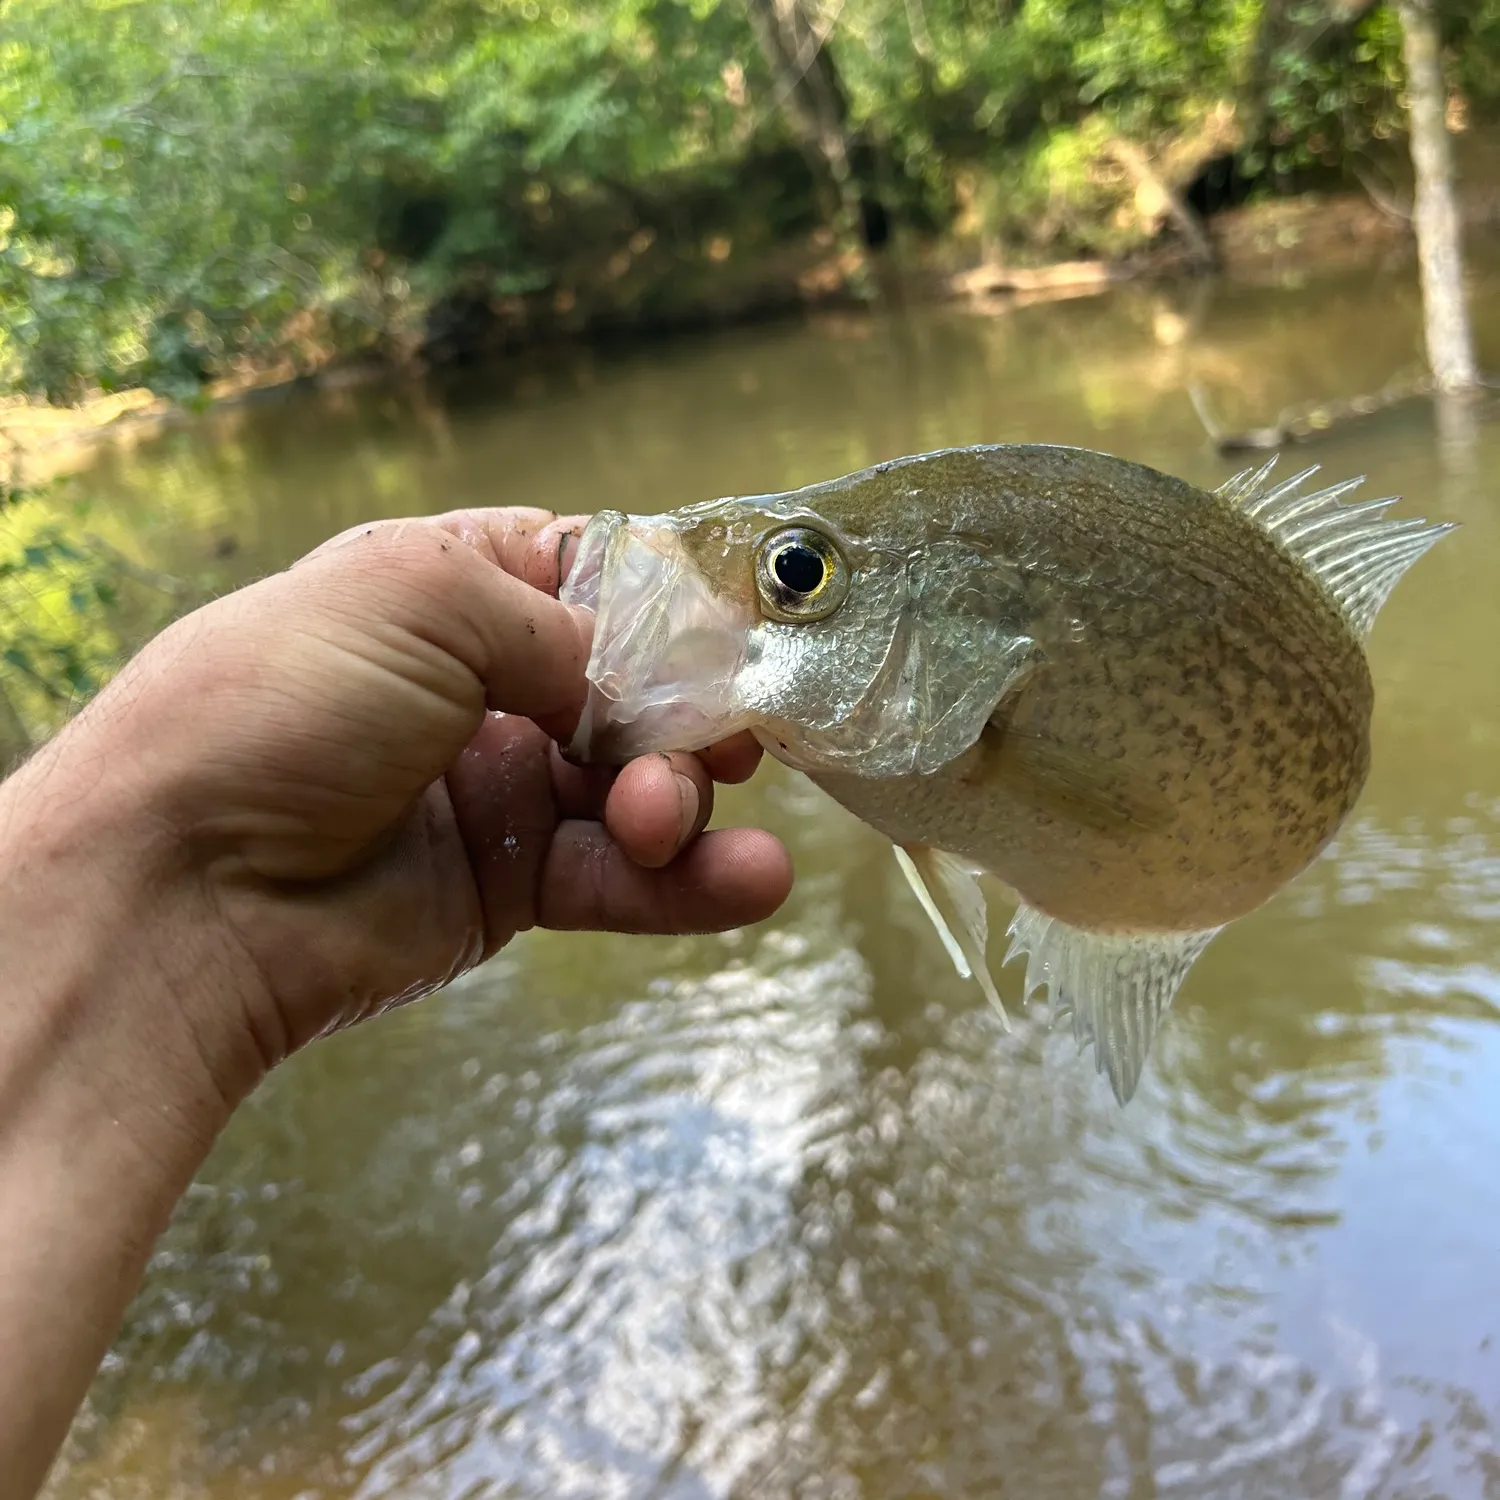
top-left (1214, 458), bottom-right (1454, 639)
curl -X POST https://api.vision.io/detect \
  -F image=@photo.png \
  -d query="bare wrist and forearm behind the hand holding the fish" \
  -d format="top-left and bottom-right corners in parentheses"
top-left (0, 716), bottom-right (270, 1494)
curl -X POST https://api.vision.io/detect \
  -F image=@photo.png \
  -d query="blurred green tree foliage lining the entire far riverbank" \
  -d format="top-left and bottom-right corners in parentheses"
top-left (0, 0), bottom-right (1500, 399)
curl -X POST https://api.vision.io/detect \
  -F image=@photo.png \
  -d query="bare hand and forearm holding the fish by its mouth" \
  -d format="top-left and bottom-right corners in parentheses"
top-left (0, 510), bottom-right (791, 1494)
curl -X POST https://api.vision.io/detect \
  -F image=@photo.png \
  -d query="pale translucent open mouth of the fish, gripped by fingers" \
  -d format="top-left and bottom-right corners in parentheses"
top-left (560, 510), bottom-right (755, 765)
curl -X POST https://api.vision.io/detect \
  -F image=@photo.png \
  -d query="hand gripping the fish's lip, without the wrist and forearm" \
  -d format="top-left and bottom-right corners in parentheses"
top-left (2, 510), bottom-right (791, 1101)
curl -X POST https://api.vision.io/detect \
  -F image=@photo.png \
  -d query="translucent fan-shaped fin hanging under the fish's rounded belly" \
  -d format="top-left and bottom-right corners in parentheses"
top-left (1005, 903), bottom-right (1223, 1104)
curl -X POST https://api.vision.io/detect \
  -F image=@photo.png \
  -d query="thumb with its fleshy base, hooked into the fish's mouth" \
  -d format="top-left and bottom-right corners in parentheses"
top-left (77, 524), bottom-right (590, 879)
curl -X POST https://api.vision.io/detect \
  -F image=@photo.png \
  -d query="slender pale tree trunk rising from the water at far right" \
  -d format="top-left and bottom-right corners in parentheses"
top-left (1397, 0), bottom-right (1479, 392)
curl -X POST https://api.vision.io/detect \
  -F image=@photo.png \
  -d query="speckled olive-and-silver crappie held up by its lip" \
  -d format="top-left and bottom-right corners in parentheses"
top-left (563, 444), bottom-right (1454, 1107)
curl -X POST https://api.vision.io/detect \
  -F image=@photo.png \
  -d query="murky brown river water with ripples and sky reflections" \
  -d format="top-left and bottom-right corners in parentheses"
top-left (29, 266), bottom-right (1500, 1500)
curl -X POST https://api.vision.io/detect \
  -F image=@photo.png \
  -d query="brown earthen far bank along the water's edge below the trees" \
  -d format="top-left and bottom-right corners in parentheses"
top-left (0, 181), bottom-right (1452, 483)
